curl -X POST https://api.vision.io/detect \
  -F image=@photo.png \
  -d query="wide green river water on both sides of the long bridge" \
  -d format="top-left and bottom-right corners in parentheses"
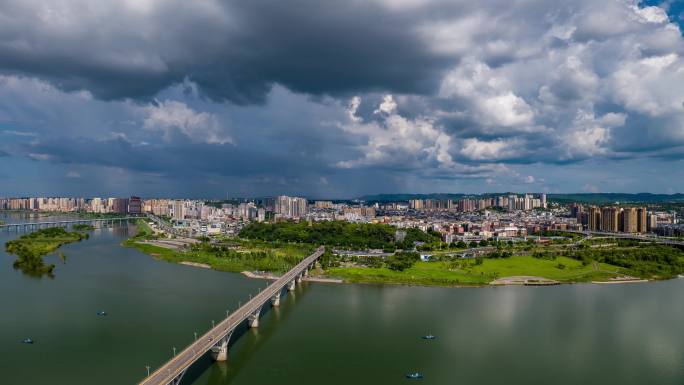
top-left (0, 213), bottom-right (684, 385)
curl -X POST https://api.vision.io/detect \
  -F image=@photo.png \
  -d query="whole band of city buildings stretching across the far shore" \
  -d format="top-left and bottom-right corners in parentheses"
top-left (0, 194), bottom-right (684, 243)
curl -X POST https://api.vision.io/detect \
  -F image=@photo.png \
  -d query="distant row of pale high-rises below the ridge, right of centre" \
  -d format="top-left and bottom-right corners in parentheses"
top-left (408, 193), bottom-right (547, 212)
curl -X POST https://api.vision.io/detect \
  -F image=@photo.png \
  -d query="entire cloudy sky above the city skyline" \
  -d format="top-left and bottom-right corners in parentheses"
top-left (0, 0), bottom-right (684, 198)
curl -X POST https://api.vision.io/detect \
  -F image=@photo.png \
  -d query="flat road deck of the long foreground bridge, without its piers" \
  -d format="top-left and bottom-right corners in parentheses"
top-left (140, 247), bottom-right (325, 385)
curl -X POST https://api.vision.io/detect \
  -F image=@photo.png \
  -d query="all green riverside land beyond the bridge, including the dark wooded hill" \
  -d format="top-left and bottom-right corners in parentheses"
top-left (125, 220), bottom-right (684, 286)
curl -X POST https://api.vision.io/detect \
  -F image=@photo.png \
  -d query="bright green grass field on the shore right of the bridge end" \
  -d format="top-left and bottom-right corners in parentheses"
top-left (326, 256), bottom-right (620, 286)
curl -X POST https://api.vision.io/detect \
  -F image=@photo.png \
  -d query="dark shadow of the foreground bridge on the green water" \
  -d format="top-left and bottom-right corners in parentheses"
top-left (181, 282), bottom-right (309, 385)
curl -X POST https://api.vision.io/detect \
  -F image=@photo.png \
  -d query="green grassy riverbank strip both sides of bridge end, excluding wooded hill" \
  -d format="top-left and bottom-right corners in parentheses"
top-left (125, 220), bottom-right (681, 287)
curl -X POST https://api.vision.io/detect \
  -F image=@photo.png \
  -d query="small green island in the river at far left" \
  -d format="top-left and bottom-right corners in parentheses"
top-left (5, 227), bottom-right (88, 277)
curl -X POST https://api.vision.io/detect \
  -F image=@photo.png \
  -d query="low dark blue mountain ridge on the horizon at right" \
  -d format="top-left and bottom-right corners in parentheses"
top-left (357, 193), bottom-right (684, 204)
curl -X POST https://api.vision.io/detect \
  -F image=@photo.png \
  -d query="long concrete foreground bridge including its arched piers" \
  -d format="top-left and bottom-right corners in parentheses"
top-left (140, 246), bottom-right (325, 385)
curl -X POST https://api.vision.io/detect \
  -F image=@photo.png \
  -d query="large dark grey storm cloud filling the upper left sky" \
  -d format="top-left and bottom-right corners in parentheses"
top-left (0, 0), bottom-right (453, 104)
